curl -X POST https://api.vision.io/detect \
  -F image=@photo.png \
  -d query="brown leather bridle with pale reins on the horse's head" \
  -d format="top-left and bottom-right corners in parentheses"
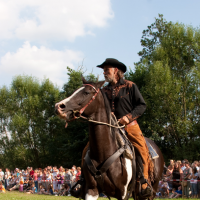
top-left (68, 84), bottom-right (125, 128)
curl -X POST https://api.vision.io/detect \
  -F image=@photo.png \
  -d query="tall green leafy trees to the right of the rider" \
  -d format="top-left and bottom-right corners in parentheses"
top-left (129, 15), bottom-right (200, 160)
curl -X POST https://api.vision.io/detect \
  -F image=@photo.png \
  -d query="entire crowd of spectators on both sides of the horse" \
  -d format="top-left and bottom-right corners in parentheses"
top-left (0, 159), bottom-right (200, 198)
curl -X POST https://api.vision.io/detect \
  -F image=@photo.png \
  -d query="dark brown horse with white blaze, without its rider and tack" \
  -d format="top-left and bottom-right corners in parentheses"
top-left (55, 79), bottom-right (164, 200)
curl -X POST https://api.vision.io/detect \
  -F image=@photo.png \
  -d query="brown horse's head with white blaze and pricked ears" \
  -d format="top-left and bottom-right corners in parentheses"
top-left (55, 76), bottom-right (105, 126)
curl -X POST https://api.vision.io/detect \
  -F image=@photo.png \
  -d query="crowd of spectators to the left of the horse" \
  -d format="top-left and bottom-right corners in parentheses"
top-left (0, 165), bottom-right (81, 196)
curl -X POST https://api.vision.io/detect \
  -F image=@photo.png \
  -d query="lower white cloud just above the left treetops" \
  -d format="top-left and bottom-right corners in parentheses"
top-left (0, 42), bottom-right (83, 87)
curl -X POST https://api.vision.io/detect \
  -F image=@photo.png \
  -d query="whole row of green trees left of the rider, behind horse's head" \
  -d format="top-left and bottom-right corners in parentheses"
top-left (0, 67), bottom-right (97, 169)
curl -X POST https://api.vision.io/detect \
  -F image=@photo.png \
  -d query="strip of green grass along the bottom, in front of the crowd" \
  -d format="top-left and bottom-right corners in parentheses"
top-left (0, 191), bottom-right (197, 200)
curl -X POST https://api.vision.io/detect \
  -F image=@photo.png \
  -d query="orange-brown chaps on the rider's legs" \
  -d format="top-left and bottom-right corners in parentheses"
top-left (82, 121), bottom-right (149, 189)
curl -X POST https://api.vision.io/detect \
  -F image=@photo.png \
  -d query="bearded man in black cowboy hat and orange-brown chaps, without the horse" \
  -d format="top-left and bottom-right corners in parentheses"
top-left (79, 58), bottom-right (152, 198)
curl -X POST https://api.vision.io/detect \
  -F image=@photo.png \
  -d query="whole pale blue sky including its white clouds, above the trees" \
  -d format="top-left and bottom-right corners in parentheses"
top-left (0, 0), bottom-right (200, 88)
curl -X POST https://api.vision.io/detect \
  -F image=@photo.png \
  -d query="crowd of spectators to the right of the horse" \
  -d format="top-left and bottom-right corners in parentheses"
top-left (156, 159), bottom-right (200, 198)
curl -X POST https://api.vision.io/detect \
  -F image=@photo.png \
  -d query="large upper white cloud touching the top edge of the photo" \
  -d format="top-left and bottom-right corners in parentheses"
top-left (0, 0), bottom-right (113, 41)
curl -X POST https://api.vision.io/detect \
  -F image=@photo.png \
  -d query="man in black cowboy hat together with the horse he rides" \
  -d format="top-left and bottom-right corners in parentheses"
top-left (55, 58), bottom-right (164, 200)
